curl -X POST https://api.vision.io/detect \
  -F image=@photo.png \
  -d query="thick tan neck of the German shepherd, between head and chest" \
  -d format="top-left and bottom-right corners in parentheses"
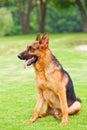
top-left (34, 49), bottom-right (62, 73)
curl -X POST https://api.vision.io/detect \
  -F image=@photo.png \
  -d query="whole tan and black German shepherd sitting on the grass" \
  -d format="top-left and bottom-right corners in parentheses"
top-left (18, 33), bottom-right (81, 124)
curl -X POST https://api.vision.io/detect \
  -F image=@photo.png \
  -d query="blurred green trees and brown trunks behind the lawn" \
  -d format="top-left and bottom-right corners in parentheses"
top-left (0, 0), bottom-right (87, 36)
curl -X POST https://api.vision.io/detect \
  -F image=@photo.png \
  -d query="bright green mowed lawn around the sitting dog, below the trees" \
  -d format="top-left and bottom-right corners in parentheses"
top-left (0, 33), bottom-right (87, 130)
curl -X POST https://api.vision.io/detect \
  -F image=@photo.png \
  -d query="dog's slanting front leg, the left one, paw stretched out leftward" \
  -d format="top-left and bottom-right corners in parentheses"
top-left (25, 94), bottom-right (44, 124)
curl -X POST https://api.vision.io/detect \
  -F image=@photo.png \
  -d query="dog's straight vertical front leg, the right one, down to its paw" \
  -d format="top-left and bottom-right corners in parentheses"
top-left (58, 86), bottom-right (68, 124)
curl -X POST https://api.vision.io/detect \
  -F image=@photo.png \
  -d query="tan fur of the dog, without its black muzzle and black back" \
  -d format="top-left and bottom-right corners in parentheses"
top-left (20, 33), bottom-right (81, 124)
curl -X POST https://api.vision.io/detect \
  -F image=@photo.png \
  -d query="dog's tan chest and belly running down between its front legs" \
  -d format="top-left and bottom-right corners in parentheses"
top-left (36, 72), bottom-right (61, 109)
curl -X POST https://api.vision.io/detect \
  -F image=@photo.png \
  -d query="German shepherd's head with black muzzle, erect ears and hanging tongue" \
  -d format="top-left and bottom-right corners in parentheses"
top-left (18, 33), bottom-right (49, 68)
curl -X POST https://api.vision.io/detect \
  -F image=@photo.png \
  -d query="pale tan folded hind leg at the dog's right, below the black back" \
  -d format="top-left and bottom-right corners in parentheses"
top-left (68, 101), bottom-right (81, 115)
